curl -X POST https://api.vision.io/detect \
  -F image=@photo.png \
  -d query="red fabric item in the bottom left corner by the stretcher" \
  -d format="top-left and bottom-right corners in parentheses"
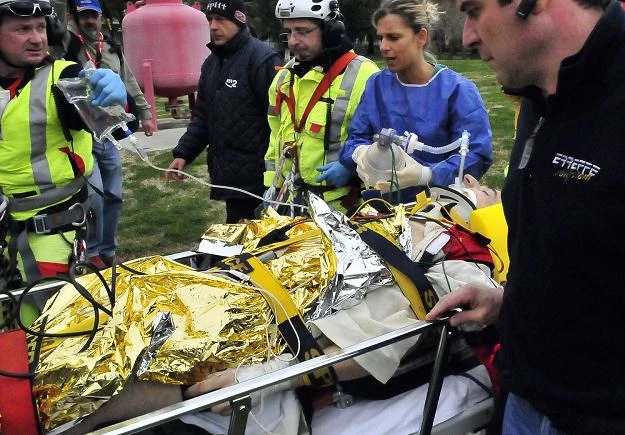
top-left (0, 329), bottom-right (39, 435)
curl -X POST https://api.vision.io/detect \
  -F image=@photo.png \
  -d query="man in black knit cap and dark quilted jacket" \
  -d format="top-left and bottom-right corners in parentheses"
top-left (166, 0), bottom-right (281, 223)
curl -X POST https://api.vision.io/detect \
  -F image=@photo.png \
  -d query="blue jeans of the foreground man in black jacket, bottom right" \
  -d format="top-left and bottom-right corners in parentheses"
top-left (502, 393), bottom-right (565, 435)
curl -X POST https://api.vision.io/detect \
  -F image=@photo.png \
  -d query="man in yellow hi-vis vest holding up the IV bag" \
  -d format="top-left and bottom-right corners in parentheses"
top-left (0, 0), bottom-right (127, 284)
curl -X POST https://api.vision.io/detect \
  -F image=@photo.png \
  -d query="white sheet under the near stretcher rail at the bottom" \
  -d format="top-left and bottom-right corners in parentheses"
top-left (181, 366), bottom-right (490, 435)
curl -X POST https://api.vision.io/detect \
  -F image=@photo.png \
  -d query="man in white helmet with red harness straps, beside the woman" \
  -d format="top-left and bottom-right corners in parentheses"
top-left (264, 0), bottom-right (378, 213)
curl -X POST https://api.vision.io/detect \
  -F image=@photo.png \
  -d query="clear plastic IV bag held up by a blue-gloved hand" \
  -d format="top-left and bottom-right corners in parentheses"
top-left (57, 61), bottom-right (147, 161)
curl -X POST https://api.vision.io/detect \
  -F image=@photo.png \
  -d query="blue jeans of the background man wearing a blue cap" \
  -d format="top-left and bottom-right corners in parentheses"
top-left (87, 140), bottom-right (122, 257)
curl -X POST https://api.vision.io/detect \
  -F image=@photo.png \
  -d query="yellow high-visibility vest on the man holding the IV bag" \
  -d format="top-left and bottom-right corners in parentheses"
top-left (0, 60), bottom-right (93, 221)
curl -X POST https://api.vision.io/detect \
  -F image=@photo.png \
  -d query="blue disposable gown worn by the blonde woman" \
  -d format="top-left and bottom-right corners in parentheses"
top-left (339, 65), bottom-right (492, 185)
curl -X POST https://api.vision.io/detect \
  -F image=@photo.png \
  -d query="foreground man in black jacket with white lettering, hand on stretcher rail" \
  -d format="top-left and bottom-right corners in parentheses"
top-left (429, 0), bottom-right (625, 434)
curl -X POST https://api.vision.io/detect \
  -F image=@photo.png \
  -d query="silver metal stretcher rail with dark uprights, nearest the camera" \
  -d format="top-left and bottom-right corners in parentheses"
top-left (92, 318), bottom-right (451, 435)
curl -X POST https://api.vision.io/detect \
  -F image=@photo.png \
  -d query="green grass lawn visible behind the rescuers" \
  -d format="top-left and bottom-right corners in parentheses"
top-left (118, 59), bottom-right (514, 258)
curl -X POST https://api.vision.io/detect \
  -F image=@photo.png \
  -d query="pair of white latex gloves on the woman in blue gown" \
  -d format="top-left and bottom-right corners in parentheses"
top-left (352, 145), bottom-right (432, 193)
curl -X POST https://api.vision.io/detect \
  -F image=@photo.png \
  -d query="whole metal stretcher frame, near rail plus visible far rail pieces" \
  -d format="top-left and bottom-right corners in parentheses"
top-left (0, 251), bottom-right (494, 435)
